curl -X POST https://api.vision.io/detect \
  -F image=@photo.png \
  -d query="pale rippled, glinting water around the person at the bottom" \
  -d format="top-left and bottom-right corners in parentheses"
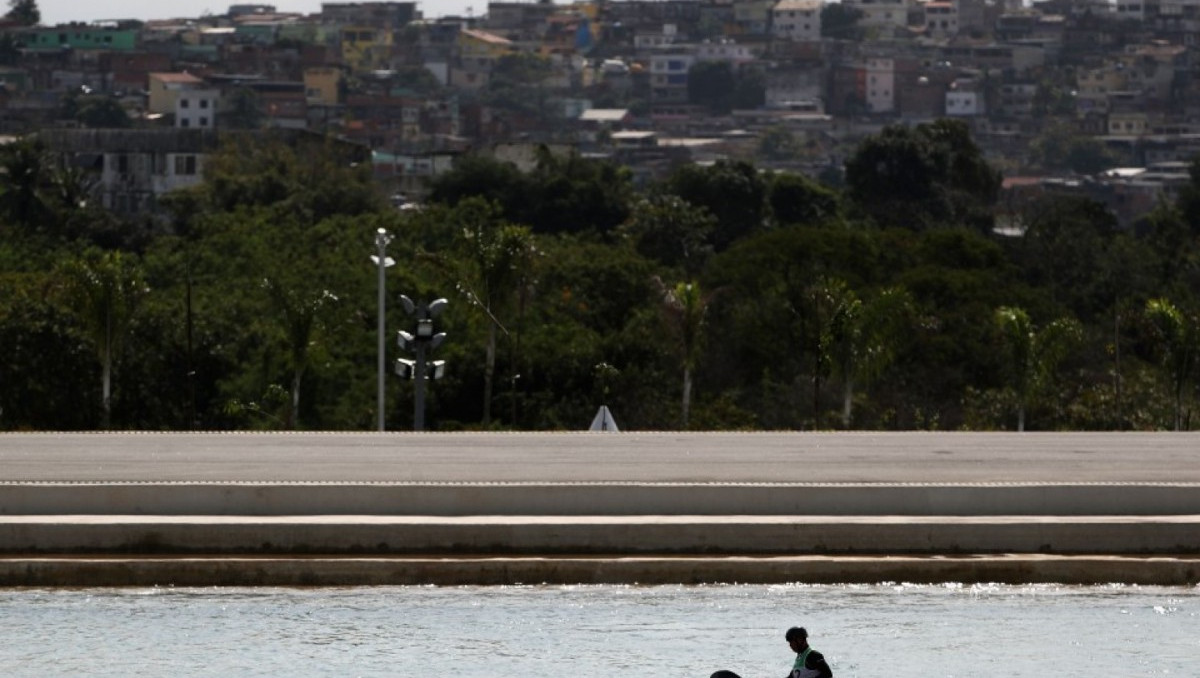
top-left (0, 584), bottom-right (1200, 678)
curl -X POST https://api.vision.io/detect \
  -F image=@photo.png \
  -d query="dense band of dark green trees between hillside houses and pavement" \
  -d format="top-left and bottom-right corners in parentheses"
top-left (0, 121), bottom-right (1200, 430)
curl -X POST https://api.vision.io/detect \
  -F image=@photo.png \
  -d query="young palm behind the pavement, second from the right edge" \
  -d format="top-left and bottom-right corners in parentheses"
top-left (995, 306), bottom-right (1082, 431)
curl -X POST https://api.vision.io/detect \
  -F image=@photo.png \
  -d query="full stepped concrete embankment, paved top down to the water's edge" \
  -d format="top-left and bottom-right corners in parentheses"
top-left (0, 433), bottom-right (1200, 586)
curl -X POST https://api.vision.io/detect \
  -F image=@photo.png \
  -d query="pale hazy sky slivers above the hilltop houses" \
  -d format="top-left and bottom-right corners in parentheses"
top-left (42, 0), bottom-right (487, 26)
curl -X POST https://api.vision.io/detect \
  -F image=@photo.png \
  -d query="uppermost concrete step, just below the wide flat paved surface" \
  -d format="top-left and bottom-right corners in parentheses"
top-left (0, 482), bottom-right (1200, 516)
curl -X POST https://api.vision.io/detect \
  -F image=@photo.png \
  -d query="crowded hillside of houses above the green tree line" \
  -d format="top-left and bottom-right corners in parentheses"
top-left (0, 0), bottom-right (1200, 224)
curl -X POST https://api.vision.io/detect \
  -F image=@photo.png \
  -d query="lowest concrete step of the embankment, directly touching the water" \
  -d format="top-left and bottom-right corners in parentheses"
top-left (0, 556), bottom-right (1200, 587)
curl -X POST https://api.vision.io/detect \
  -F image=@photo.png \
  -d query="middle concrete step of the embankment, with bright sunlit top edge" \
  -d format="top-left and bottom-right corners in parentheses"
top-left (0, 515), bottom-right (1200, 556)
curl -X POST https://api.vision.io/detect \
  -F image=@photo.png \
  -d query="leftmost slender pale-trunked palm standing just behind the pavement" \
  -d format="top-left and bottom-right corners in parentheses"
top-left (60, 250), bottom-right (146, 428)
